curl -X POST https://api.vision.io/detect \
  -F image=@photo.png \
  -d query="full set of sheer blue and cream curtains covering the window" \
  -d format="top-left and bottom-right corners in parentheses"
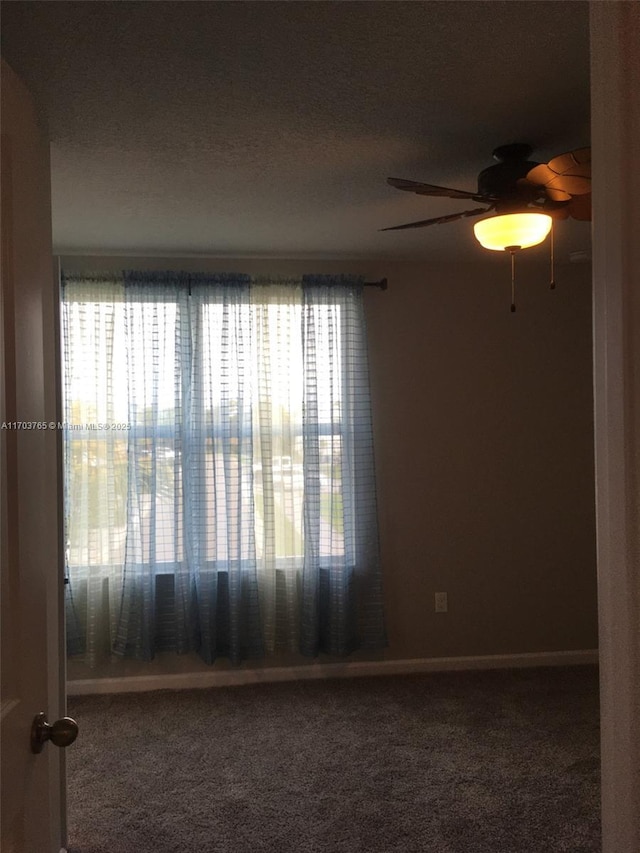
top-left (62, 272), bottom-right (385, 664)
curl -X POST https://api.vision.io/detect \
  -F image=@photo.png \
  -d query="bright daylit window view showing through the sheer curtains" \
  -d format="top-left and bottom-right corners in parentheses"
top-left (65, 287), bottom-right (345, 571)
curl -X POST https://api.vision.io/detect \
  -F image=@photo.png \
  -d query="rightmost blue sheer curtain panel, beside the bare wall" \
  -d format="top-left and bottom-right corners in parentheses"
top-left (300, 276), bottom-right (383, 654)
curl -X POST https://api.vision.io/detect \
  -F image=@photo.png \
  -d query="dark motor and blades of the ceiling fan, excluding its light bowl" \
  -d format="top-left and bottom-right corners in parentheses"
top-left (381, 142), bottom-right (591, 240)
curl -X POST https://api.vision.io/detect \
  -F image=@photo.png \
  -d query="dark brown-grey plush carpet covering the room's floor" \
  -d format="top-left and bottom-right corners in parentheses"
top-left (67, 667), bottom-right (600, 853)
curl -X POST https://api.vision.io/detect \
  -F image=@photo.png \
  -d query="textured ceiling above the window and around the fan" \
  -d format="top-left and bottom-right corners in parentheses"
top-left (2, 0), bottom-right (590, 259)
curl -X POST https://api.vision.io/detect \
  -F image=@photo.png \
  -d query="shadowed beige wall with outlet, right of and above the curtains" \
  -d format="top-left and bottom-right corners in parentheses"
top-left (63, 251), bottom-right (597, 677)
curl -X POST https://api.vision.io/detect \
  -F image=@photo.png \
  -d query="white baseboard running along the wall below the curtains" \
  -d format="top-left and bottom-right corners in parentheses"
top-left (67, 649), bottom-right (598, 696)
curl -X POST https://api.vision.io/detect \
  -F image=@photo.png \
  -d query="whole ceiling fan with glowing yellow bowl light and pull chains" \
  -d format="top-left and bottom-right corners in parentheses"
top-left (381, 142), bottom-right (591, 311)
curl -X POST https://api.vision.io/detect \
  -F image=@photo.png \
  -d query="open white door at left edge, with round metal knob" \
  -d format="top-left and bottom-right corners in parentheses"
top-left (0, 62), bottom-right (65, 853)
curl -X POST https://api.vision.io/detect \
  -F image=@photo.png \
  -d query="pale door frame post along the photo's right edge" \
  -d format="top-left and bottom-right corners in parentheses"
top-left (589, 0), bottom-right (640, 853)
